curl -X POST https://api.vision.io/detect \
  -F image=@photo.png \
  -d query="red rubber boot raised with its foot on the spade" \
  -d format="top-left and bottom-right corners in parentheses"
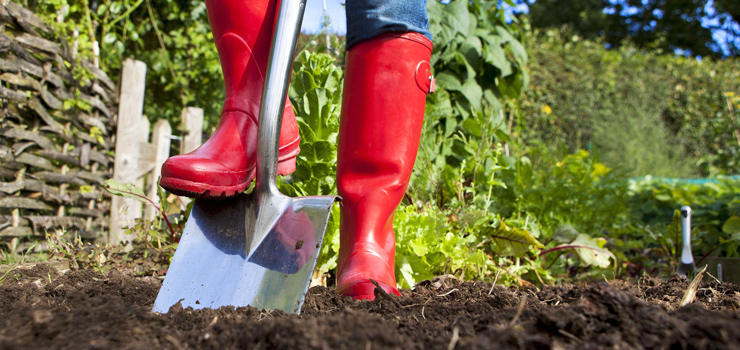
top-left (159, 0), bottom-right (300, 199)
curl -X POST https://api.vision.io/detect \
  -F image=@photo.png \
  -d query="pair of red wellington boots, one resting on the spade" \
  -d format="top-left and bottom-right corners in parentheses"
top-left (160, 0), bottom-right (433, 300)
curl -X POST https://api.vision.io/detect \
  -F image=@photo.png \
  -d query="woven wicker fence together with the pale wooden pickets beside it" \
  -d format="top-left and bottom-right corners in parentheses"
top-left (0, 1), bottom-right (203, 251)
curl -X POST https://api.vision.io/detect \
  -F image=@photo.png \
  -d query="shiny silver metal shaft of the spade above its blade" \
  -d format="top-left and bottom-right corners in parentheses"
top-left (255, 0), bottom-right (306, 194)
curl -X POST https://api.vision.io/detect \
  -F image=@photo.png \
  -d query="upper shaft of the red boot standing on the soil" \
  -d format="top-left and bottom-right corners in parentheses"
top-left (337, 33), bottom-right (432, 221)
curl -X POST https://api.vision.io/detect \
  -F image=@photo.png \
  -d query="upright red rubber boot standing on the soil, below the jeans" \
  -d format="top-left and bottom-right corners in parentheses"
top-left (337, 32), bottom-right (433, 300)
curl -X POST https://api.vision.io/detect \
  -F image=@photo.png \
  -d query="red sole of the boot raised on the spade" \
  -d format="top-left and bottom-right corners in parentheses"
top-left (159, 156), bottom-right (295, 200)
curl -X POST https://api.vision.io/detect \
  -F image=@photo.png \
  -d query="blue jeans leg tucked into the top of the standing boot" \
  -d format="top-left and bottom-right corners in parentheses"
top-left (345, 0), bottom-right (432, 49)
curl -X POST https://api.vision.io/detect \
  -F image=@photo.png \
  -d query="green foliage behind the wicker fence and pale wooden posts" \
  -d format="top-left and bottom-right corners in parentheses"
top-left (29, 0), bottom-right (224, 130)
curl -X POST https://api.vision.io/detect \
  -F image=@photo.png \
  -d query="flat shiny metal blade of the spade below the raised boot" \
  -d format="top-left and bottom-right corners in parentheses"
top-left (153, 194), bottom-right (335, 313)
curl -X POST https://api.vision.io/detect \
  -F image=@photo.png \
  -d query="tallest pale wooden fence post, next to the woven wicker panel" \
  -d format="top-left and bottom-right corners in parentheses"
top-left (108, 59), bottom-right (146, 243)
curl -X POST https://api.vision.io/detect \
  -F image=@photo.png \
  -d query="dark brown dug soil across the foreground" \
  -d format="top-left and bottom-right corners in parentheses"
top-left (0, 265), bottom-right (740, 350)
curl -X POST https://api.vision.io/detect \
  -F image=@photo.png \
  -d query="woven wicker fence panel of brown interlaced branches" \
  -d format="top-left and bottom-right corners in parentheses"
top-left (0, 2), bottom-right (119, 250)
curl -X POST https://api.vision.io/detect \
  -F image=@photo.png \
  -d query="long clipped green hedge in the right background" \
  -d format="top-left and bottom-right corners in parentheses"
top-left (520, 30), bottom-right (740, 177)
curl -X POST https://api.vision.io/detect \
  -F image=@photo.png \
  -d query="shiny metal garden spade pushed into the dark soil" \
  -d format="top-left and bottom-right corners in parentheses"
top-left (153, 0), bottom-right (338, 313)
